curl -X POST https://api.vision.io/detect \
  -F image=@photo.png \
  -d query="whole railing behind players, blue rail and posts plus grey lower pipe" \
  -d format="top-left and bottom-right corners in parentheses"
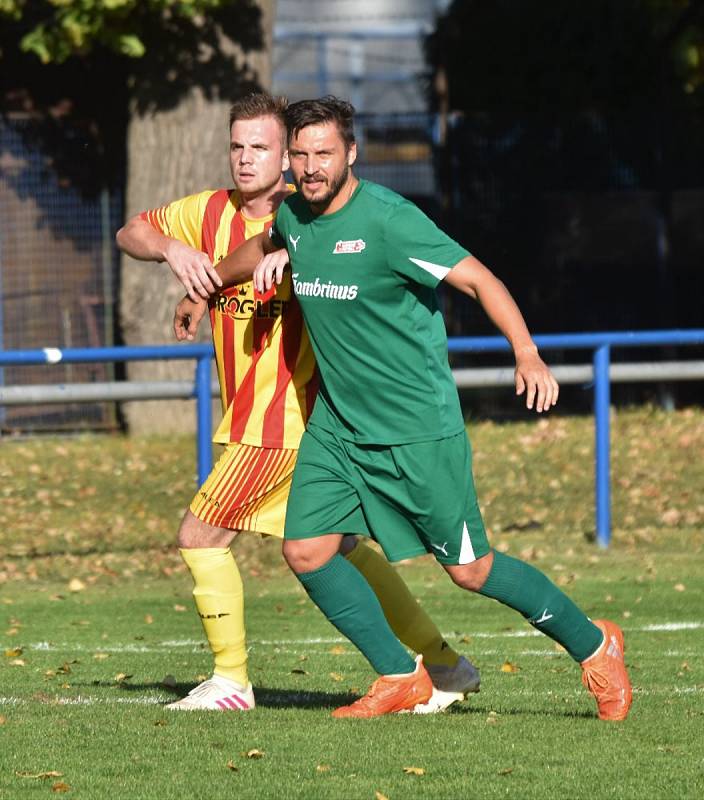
top-left (0, 329), bottom-right (704, 547)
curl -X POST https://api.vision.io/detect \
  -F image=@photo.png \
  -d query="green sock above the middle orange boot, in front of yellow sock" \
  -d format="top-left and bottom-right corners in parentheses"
top-left (297, 553), bottom-right (416, 675)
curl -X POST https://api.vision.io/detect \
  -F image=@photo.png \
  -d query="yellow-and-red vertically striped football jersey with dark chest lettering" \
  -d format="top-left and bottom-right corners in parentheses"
top-left (141, 187), bottom-right (317, 448)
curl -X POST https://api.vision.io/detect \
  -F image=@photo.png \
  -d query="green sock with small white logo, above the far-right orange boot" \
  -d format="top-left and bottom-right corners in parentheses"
top-left (479, 550), bottom-right (604, 662)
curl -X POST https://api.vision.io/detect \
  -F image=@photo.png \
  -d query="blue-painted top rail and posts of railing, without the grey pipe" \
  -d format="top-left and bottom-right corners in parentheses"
top-left (0, 329), bottom-right (704, 547)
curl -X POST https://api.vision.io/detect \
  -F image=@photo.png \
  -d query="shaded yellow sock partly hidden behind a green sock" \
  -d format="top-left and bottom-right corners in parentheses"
top-left (346, 541), bottom-right (459, 667)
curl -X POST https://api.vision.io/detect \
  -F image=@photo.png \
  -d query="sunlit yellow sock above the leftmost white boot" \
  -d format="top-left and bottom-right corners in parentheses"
top-left (179, 547), bottom-right (249, 686)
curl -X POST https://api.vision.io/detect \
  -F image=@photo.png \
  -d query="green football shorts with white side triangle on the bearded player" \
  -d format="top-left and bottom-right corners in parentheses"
top-left (284, 427), bottom-right (489, 564)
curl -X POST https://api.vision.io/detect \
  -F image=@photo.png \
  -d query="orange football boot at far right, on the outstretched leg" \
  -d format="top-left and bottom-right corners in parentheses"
top-left (581, 619), bottom-right (632, 721)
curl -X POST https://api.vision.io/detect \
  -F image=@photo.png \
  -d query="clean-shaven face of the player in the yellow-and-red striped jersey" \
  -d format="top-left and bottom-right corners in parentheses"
top-left (230, 117), bottom-right (288, 195)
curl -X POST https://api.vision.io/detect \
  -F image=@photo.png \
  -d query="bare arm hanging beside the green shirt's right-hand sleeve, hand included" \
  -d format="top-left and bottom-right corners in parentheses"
top-left (445, 256), bottom-right (559, 413)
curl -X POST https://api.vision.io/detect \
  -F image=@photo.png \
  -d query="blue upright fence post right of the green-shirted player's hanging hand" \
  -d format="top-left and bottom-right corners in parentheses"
top-left (594, 344), bottom-right (611, 547)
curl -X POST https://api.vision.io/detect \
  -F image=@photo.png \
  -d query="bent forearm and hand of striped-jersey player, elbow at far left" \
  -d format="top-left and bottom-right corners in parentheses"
top-left (115, 215), bottom-right (222, 301)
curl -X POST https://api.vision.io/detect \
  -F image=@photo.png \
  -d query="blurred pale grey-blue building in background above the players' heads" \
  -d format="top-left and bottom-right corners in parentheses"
top-left (272, 0), bottom-right (449, 198)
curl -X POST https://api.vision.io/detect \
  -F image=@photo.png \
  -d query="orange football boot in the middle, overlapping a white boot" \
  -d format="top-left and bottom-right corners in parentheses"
top-left (332, 656), bottom-right (433, 719)
